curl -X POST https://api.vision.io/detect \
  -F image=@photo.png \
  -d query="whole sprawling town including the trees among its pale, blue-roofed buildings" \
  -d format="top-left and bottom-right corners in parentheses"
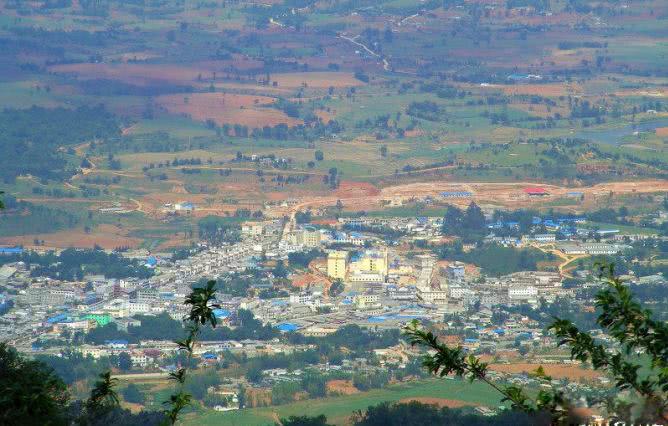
top-left (0, 188), bottom-right (667, 420)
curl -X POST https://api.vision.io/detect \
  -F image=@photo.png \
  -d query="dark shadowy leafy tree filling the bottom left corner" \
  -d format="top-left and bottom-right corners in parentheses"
top-left (0, 343), bottom-right (69, 425)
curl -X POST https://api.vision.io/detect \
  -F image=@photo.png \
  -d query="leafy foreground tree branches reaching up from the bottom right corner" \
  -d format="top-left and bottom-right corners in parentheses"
top-left (405, 265), bottom-right (668, 424)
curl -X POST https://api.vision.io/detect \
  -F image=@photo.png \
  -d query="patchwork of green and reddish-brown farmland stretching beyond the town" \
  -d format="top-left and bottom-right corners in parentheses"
top-left (0, 0), bottom-right (668, 249)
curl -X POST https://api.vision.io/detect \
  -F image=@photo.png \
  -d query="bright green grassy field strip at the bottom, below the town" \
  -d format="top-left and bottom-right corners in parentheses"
top-left (184, 380), bottom-right (500, 426)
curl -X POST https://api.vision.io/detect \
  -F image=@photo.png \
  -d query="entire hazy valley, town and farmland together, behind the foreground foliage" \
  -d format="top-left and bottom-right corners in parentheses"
top-left (0, 0), bottom-right (668, 425)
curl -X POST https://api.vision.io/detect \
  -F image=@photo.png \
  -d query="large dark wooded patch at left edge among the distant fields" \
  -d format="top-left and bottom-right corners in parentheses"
top-left (0, 106), bottom-right (120, 182)
